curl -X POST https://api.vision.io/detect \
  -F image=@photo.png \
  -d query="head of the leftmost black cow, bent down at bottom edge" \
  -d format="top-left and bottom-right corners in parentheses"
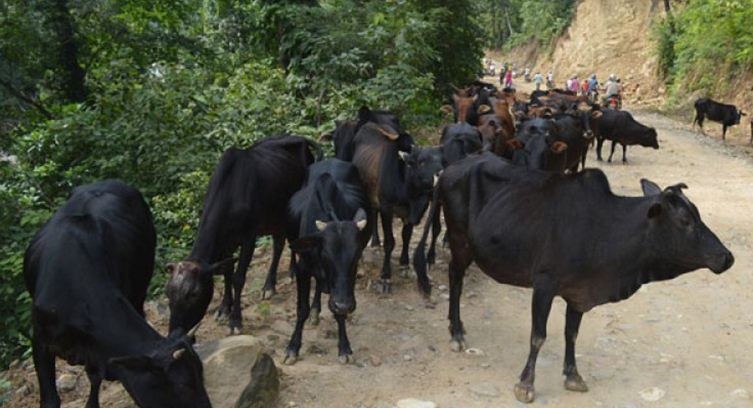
top-left (107, 329), bottom-right (212, 408)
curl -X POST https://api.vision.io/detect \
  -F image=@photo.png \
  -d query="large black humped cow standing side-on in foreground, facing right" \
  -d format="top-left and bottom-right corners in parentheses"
top-left (438, 154), bottom-right (734, 402)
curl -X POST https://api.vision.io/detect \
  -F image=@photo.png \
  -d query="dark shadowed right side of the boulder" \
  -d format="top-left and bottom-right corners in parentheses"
top-left (235, 353), bottom-right (280, 408)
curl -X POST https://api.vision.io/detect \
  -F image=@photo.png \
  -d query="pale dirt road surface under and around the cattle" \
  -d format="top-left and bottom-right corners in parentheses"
top-left (8, 80), bottom-right (753, 408)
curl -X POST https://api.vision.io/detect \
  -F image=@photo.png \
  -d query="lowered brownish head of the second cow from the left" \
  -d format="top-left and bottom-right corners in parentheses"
top-left (165, 258), bottom-right (235, 331)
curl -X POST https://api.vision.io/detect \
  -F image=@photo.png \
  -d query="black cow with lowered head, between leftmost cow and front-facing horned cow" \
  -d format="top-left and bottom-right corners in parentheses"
top-left (166, 135), bottom-right (318, 334)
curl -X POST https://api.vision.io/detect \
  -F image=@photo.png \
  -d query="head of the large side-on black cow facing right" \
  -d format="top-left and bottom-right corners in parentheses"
top-left (641, 179), bottom-right (735, 274)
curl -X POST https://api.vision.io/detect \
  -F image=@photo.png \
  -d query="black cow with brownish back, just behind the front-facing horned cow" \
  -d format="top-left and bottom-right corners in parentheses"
top-left (353, 115), bottom-right (442, 293)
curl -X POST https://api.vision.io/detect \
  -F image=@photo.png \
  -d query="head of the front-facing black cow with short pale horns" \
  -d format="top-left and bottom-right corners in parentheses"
top-left (290, 208), bottom-right (368, 315)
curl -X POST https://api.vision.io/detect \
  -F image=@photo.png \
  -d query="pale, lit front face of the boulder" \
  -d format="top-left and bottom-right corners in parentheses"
top-left (195, 335), bottom-right (276, 408)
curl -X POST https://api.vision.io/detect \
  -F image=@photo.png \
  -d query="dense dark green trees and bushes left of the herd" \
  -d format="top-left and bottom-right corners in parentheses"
top-left (0, 0), bottom-right (482, 365)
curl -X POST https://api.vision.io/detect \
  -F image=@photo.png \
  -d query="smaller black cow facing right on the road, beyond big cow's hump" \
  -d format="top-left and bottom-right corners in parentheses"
top-left (594, 109), bottom-right (659, 163)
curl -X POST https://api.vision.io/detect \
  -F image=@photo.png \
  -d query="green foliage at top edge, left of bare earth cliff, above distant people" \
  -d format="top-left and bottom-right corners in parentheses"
top-left (475, 0), bottom-right (576, 49)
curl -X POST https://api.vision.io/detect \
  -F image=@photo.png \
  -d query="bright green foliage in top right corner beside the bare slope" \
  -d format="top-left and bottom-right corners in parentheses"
top-left (654, 0), bottom-right (753, 94)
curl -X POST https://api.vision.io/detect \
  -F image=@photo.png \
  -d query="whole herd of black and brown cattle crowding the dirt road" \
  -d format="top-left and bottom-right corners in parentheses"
top-left (24, 82), bottom-right (734, 407)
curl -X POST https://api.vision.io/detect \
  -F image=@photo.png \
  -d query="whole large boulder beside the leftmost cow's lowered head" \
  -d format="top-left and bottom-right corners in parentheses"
top-left (196, 336), bottom-right (280, 408)
